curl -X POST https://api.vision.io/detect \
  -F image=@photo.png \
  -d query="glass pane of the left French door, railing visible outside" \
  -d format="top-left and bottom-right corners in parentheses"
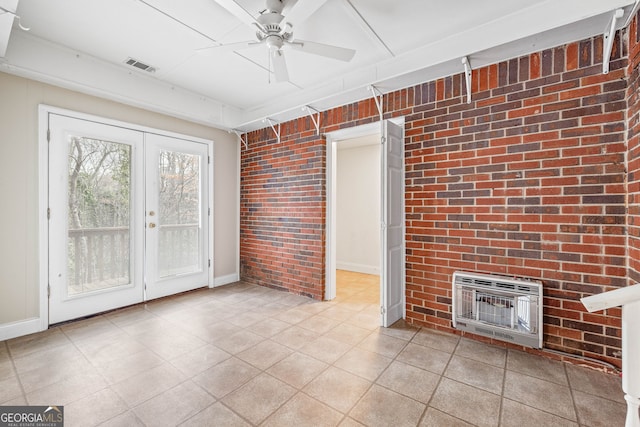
top-left (67, 136), bottom-right (131, 296)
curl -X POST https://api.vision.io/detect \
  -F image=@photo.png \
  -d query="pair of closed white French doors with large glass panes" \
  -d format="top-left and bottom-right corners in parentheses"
top-left (48, 114), bottom-right (210, 324)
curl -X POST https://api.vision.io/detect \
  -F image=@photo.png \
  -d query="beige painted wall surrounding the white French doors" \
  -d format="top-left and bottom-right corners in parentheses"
top-left (0, 72), bottom-right (239, 340)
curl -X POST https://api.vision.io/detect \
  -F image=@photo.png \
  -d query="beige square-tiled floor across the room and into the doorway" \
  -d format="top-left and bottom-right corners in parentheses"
top-left (0, 272), bottom-right (625, 427)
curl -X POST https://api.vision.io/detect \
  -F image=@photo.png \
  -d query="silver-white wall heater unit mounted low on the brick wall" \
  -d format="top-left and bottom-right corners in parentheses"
top-left (452, 271), bottom-right (542, 348)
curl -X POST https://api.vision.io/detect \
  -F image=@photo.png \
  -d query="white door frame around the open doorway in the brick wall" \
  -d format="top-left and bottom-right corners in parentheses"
top-left (324, 117), bottom-right (406, 318)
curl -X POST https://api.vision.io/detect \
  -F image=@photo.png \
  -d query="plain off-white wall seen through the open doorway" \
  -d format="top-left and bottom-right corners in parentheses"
top-left (336, 139), bottom-right (380, 274)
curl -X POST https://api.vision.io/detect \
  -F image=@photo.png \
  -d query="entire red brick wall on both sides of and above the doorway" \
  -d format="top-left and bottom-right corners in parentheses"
top-left (241, 28), bottom-right (640, 364)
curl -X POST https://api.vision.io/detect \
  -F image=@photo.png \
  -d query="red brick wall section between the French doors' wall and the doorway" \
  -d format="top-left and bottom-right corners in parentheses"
top-left (240, 126), bottom-right (326, 299)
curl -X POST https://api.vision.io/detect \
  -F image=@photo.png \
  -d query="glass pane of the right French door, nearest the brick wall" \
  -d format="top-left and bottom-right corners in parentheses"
top-left (158, 150), bottom-right (202, 277)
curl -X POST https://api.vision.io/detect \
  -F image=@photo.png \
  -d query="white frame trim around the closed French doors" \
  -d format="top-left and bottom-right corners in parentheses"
top-left (38, 104), bottom-right (214, 331)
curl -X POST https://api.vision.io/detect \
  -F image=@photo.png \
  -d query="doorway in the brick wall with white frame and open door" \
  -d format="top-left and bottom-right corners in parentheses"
top-left (325, 118), bottom-right (405, 327)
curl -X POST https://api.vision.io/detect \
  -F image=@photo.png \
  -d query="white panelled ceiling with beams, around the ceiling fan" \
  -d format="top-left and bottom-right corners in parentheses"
top-left (0, 0), bottom-right (638, 131)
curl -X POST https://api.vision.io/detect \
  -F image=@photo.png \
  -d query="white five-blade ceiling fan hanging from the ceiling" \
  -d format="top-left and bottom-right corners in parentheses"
top-left (198, 0), bottom-right (356, 82)
